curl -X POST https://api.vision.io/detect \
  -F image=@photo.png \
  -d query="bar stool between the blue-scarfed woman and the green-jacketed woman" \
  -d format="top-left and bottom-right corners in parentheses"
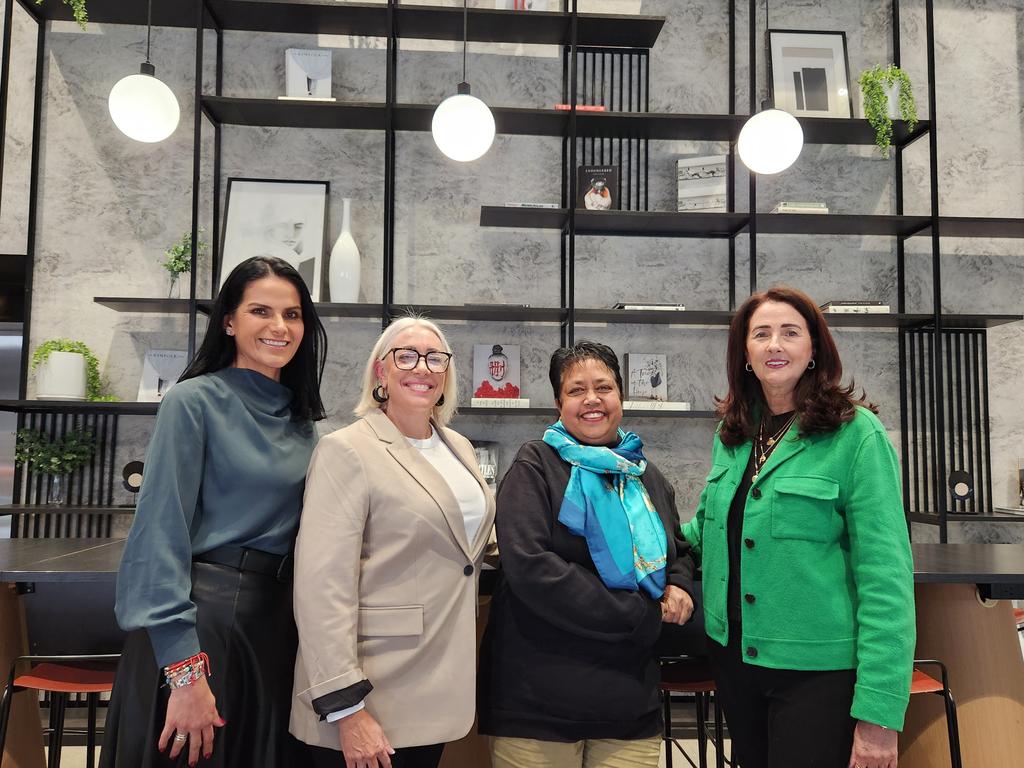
top-left (659, 656), bottom-right (726, 768)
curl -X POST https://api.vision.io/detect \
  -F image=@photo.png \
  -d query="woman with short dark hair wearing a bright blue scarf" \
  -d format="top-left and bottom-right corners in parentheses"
top-left (479, 341), bottom-right (693, 768)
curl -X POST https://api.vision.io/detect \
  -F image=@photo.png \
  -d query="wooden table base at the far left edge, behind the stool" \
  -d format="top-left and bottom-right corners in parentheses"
top-left (0, 584), bottom-right (45, 768)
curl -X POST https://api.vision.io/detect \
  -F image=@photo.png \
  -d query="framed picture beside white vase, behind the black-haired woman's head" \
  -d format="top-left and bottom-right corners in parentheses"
top-left (217, 178), bottom-right (331, 301)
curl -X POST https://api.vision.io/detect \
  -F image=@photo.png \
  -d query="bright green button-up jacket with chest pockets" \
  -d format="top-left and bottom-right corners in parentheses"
top-left (683, 408), bottom-right (915, 729)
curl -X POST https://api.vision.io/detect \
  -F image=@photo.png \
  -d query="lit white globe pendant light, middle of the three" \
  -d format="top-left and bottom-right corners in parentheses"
top-left (430, 0), bottom-right (495, 163)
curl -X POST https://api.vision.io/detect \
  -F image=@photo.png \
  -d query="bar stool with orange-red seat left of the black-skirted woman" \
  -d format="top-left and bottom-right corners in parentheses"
top-left (0, 653), bottom-right (121, 768)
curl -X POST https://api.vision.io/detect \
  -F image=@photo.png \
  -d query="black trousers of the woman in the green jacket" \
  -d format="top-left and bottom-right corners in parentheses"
top-left (708, 626), bottom-right (856, 768)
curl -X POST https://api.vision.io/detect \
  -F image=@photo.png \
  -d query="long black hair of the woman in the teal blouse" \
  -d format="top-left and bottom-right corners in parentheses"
top-left (178, 256), bottom-right (327, 421)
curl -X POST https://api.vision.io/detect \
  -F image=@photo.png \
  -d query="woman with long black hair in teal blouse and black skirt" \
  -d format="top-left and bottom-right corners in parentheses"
top-left (100, 256), bottom-right (327, 768)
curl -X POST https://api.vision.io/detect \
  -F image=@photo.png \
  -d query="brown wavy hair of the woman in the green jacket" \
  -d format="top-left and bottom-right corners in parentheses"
top-left (716, 286), bottom-right (878, 445)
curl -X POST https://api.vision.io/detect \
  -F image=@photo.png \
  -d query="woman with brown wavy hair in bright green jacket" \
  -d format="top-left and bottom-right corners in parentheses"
top-left (683, 287), bottom-right (914, 768)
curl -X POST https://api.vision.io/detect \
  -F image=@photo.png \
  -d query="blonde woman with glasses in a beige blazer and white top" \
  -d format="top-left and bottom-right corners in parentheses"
top-left (291, 317), bottom-right (495, 768)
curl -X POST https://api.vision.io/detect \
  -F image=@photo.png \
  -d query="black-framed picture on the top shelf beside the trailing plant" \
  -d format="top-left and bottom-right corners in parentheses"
top-left (768, 30), bottom-right (853, 118)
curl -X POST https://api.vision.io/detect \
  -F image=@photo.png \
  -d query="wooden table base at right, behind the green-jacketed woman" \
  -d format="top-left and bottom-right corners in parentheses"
top-left (899, 584), bottom-right (1024, 768)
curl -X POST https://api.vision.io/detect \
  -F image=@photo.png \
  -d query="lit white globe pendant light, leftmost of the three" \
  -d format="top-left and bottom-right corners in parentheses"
top-left (108, 0), bottom-right (181, 143)
